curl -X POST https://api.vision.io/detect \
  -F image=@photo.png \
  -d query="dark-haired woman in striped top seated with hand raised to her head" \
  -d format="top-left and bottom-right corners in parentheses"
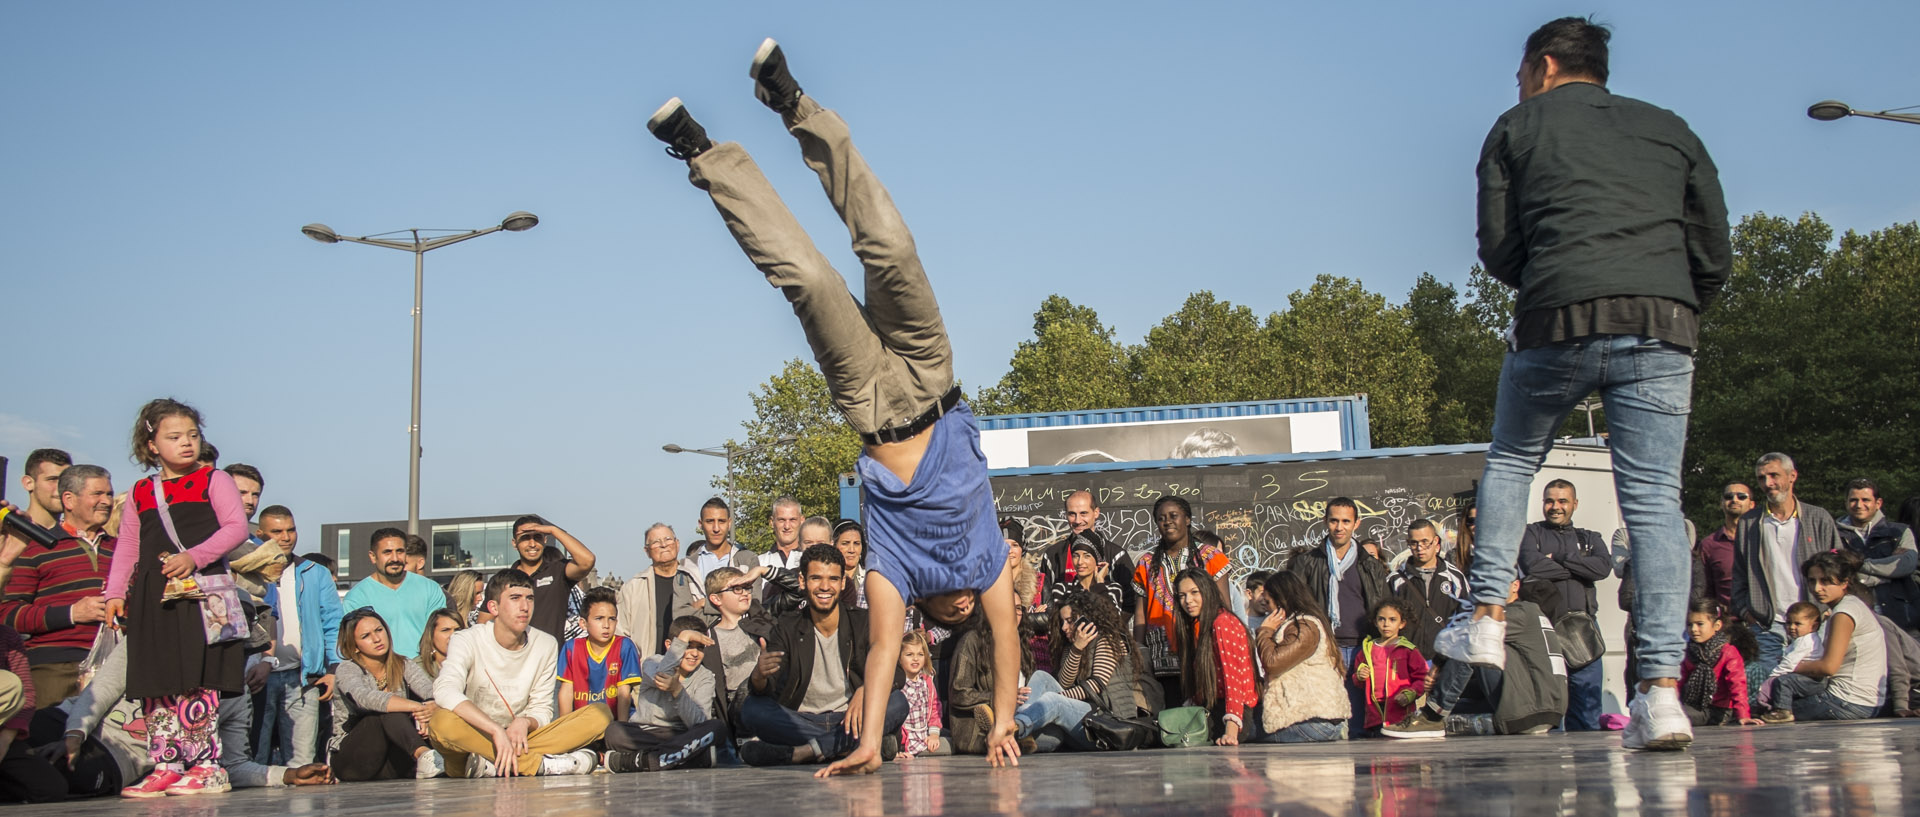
top-left (1048, 591), bottom-right (1140, 717)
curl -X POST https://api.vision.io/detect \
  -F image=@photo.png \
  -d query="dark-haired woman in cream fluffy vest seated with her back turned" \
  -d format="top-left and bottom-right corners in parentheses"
top-left (1254, 572), bottom-right (1354, 744)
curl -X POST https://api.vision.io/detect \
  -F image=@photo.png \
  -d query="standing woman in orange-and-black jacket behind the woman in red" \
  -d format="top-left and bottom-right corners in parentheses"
top-left (1133, 497), bottom-right (1233, 702)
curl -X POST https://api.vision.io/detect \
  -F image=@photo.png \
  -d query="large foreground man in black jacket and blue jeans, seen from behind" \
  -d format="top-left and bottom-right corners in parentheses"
top-left (1467, 17), bottom-right (1732, 750)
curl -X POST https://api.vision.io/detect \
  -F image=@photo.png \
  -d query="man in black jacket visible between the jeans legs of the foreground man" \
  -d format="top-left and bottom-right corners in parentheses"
top-left (1521, 479), bottom-right (1612, 733)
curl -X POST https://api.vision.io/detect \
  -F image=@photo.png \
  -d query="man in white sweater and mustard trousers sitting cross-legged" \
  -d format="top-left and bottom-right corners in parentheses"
top-left (426, 570), bottom-right (612, 777)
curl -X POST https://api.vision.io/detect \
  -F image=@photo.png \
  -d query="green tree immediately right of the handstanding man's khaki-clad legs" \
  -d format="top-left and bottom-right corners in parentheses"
top-left (975, 295), bottom-right (1131, 414)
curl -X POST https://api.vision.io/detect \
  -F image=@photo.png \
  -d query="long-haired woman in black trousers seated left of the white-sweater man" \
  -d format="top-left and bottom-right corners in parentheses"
top-left (326, 608), bottom-right (445, 782)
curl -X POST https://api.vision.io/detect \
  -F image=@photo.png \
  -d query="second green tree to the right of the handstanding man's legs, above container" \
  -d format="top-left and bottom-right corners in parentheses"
top-left (1131, 290), bottom-right (1286, 407)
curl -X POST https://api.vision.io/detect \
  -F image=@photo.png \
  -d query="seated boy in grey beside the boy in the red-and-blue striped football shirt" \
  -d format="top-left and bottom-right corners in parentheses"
top-left (607, 616), bottom-right (726, 771)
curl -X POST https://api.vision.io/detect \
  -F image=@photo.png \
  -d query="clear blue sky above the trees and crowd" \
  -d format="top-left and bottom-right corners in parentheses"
top-left (0, 2), bottom-right (1920, 575)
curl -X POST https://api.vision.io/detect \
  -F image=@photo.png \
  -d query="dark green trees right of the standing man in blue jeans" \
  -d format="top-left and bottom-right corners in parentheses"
top-left (1686, 213), bottom-right (1920, 525)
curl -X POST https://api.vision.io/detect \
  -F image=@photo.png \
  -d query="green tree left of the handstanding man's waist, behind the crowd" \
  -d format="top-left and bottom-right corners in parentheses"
top-left (712, 359), bottom-right (860, 552)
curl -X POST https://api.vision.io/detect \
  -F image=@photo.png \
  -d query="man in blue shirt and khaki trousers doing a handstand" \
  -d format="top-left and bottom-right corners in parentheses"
top-left (647, 38), bottom-right (1021, 777)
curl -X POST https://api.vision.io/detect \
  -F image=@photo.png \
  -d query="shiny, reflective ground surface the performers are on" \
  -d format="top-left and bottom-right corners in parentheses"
top-left (6, 721), bottom-right (1920, 817)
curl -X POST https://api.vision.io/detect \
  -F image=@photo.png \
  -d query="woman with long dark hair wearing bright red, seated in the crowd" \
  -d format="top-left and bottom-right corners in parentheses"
top-left (1173, 568), bottom-right (1258, 746)
